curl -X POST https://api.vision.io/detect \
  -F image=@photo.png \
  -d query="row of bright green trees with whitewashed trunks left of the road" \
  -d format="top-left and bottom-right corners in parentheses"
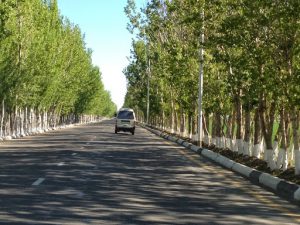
top-left (0, 0), bottom-right (116, 138)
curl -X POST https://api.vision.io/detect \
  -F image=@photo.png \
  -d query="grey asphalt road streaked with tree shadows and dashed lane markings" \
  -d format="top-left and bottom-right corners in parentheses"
top-left (0, 121), bottom-right (300, 225)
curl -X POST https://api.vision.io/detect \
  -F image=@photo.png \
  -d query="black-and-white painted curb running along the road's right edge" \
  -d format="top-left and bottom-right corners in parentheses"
top-left (143, 126), bottom-right (300, 204)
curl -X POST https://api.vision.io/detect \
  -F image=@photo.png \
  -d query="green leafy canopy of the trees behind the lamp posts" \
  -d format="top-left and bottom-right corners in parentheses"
top-left (125, 0), bottom-right (300, 125)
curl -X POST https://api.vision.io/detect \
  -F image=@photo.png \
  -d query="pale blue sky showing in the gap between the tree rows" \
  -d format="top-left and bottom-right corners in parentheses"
top-left (58, 0), bottom-right (146, 109)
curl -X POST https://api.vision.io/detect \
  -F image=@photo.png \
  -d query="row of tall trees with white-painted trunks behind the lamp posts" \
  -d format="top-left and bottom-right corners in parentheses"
top-left (124, 0), bottom-right (300, 174)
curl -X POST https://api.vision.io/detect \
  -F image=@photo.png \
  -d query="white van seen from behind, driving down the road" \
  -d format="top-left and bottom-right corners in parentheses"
top-left (115, 108), bottom-right (135, 135)
